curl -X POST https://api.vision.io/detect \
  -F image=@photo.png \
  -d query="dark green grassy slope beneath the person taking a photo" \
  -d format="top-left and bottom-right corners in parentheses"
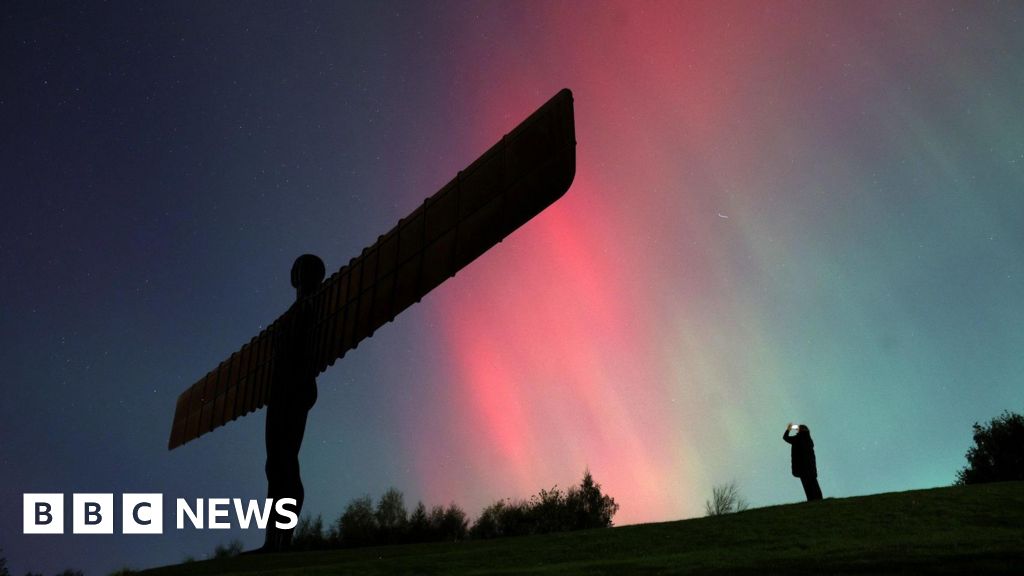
top-left (143, 482), bottom-right (1024, 576)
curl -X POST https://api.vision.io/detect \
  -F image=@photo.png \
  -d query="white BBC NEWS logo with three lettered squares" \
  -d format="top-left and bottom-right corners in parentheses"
top-left (22, 493), bottom-right (299, 534)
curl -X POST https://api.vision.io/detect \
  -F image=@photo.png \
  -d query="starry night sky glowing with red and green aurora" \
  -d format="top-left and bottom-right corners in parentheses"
top-left (0, 1), bottom-right (1024, 575)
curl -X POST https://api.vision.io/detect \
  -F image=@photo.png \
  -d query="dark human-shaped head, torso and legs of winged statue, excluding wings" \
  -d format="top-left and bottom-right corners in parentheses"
top-left (260, 254), bottom-right (325, 552)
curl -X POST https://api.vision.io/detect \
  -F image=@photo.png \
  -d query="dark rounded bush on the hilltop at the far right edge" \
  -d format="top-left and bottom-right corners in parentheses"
top-left (955, 411), bottom-right (1024, 486)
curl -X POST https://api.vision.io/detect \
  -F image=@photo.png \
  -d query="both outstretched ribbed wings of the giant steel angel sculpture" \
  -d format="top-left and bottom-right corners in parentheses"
top-left (168, 89), bottom-right (575, 450)
